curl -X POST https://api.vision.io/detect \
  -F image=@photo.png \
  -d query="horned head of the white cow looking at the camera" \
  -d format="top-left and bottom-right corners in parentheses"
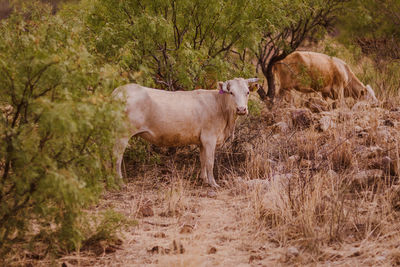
top-left (218, 78), bottom-right (258, 115)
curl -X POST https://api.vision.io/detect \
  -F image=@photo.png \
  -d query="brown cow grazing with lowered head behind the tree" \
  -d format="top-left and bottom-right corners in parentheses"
top-left (273, 51), bottom-right (377, 102)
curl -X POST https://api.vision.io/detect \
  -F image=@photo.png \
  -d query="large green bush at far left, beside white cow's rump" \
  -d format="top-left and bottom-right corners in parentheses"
top-left (0, 1), bottom-right (123, 254)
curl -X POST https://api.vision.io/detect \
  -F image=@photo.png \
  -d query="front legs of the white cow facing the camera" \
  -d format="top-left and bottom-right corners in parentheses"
top-left (200, 138), bottom-right (220, 188)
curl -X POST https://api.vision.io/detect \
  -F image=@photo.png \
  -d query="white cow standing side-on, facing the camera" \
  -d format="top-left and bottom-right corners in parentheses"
top-left (113, 78), bottom-right (258, 187)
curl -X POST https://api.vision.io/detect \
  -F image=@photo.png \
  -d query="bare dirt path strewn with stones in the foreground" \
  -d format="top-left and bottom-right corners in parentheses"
top-left (86, 184), bottom-right (268, 266)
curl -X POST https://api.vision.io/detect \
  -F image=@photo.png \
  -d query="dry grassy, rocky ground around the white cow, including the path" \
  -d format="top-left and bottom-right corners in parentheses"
top-left (19, 90), bottom-right (400, 266)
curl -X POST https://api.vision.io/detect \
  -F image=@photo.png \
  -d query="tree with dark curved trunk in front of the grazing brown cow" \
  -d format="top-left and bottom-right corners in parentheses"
top-left (252, 0), bottom-right (345, 101)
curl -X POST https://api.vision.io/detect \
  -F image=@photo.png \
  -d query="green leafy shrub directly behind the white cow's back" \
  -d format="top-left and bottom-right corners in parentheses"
top-left (85, 0), bottom-right (253, 90)
